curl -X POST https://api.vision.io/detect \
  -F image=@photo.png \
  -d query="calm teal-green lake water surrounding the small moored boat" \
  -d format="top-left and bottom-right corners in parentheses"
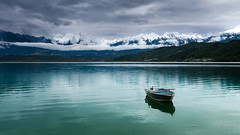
top-left (0, 63), bottom-right (240, 135)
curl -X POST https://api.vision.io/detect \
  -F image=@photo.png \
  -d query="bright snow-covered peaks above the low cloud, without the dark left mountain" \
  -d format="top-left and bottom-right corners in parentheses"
top-left (53, 28), bottom-right (240, 49)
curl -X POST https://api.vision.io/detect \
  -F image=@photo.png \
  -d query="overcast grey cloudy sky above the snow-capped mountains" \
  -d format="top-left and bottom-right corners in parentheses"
top-left (0, 0), bottom-right (240, 39)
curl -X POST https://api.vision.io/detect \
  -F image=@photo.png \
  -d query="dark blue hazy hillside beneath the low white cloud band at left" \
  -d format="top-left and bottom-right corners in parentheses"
top-left (0, 43), bottom-right (146, 62)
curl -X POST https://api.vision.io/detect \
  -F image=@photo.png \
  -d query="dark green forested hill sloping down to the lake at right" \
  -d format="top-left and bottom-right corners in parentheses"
top-left (113, 40), bottom-right (240, 62)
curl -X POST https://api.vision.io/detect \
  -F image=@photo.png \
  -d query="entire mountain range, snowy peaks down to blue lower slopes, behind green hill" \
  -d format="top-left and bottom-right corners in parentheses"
top-left (0, 30), bottom-right (240, 61)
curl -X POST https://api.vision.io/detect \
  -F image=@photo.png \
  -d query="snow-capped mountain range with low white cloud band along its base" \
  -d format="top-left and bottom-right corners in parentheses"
top-left (0, 27), bottom-right (240, 51)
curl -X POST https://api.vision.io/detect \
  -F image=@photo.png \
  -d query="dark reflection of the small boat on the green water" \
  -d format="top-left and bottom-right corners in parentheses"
top-left (145, 96), bottom-right (175, 115)
